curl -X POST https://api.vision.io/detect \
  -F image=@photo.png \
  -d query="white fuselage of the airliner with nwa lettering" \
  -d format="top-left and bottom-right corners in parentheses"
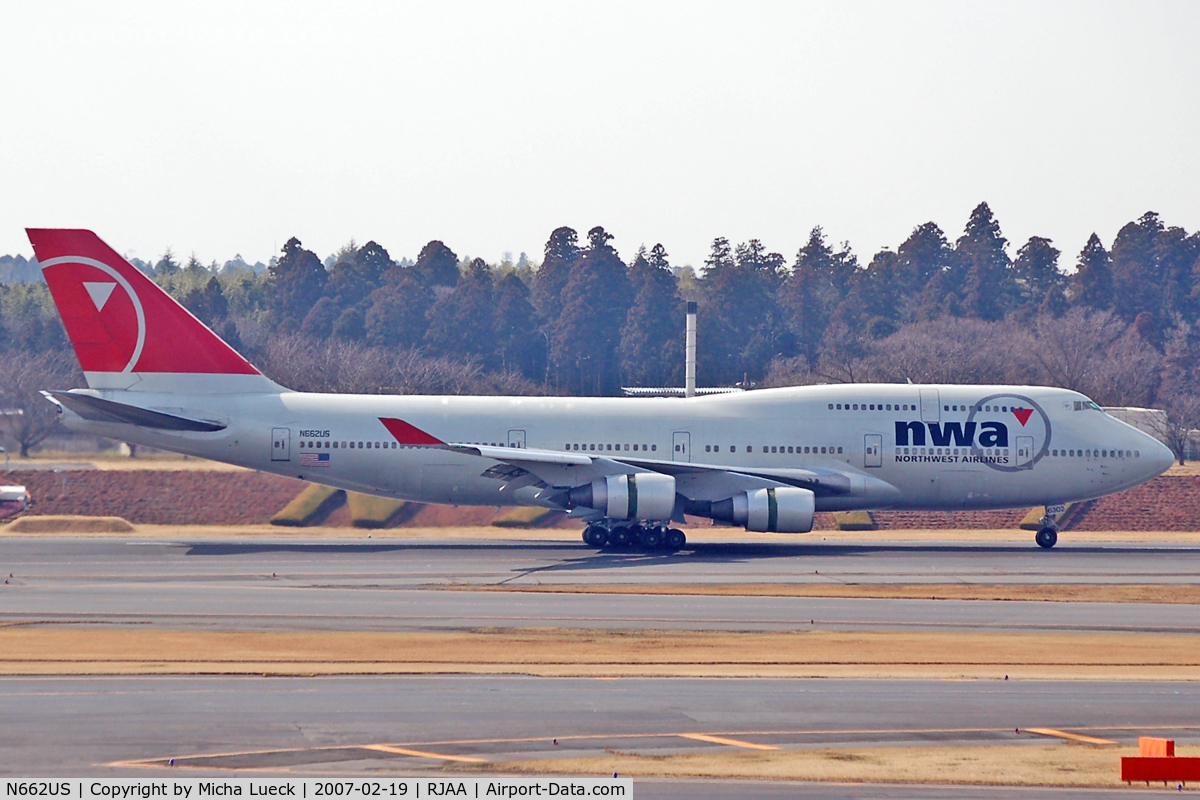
top-left (65, 384), bottom-right (1171, 511)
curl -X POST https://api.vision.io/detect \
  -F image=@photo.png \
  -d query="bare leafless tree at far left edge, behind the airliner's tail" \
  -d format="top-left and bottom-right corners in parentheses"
top-left (0, 350), bottom-right (80, 458)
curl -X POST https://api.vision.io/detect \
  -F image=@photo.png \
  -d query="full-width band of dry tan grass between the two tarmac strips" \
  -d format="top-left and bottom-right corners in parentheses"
top-left (7, 625), bottom-right (1200, 680)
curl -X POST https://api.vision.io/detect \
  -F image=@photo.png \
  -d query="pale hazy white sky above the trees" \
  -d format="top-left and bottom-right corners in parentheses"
top-left (0, 0), bottom-right (1200, 266)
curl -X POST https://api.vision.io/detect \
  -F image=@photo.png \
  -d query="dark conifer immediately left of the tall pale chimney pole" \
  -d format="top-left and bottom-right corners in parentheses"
top-left (620, 245), bottom-right (685, 386)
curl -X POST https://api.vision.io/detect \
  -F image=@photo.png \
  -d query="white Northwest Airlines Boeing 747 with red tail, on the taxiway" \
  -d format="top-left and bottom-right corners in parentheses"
top-left (28, 229), bottom-right (1172, 549)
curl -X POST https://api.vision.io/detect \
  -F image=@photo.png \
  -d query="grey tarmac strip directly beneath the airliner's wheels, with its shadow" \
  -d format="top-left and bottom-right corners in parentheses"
top-left (0, 539), bottom-right (1200, 633)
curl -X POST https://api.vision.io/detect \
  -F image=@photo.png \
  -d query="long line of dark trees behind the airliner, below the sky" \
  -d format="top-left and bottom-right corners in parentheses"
top-left (0, 203), bottom-right (1200, 455)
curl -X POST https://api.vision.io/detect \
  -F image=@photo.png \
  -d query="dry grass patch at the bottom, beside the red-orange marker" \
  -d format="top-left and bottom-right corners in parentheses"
top-left (470, 744), bottom-right (1200, 787)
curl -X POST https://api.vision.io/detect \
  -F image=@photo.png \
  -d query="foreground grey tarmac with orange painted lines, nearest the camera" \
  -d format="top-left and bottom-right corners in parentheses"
top-left (0, 676), bottom-right (1200, 794)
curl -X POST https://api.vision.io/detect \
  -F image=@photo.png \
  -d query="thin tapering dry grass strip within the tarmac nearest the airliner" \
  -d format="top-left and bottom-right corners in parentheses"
top-left (477, 583), bottom-right (1200, 604)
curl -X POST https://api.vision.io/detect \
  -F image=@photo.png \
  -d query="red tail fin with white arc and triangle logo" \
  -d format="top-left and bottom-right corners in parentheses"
top-left (26, 229), bottom-right (274, 391)
